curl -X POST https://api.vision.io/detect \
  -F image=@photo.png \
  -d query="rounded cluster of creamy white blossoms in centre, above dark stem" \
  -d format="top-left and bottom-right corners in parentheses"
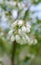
top-left (8, 20), bottom-right (31, 44)
